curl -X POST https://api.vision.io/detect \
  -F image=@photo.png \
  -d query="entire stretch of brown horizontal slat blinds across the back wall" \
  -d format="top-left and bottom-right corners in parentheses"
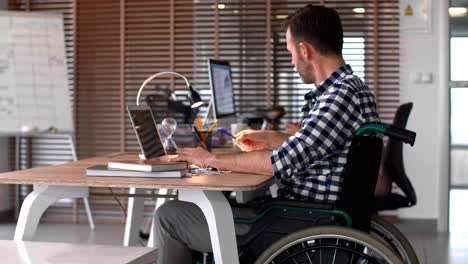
top-left (9, 0), bottom-right (399, 222)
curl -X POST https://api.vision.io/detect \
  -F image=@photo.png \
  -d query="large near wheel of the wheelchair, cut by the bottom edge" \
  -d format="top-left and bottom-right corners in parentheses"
top-left (255, 226), bottom-right (401, 264)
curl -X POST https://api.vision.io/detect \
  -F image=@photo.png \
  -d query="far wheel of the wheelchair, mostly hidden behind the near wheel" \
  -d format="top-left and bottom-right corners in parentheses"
top-left (371, 215), bottom-right (419, 264)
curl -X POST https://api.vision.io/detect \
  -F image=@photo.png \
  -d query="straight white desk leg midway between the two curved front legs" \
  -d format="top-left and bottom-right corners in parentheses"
top-left (123, 188), bottom-right (146, 247)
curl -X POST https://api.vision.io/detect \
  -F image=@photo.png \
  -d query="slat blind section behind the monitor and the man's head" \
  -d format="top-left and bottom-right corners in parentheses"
top-left (195, 0), bottom-right (399, 122)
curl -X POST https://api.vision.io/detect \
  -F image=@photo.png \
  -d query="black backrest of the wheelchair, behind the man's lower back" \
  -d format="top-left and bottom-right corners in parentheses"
top-left (337, 135), bottom-right (383, 232)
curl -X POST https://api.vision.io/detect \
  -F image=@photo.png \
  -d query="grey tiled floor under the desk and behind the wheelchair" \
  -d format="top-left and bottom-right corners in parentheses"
top-left (0, 221), bottom-right (468, 264)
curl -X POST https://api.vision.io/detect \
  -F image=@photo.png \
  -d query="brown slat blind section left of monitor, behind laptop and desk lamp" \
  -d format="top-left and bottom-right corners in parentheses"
top-left (10, 0), bottom-right (196, 222)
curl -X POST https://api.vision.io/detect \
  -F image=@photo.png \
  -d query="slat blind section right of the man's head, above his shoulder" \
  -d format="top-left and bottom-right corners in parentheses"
top-left (325, 0), bottom-right (400, 122)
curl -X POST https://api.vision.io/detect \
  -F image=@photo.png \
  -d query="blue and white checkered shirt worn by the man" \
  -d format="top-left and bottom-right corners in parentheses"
top-left (270, 65), bottom-right (379, 203)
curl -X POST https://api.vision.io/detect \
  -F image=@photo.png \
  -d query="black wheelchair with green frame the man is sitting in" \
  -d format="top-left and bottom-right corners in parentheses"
top-left (197, 123), bottom-right (416, 264)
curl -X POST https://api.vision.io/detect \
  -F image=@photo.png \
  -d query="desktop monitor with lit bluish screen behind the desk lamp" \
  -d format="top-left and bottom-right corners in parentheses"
top-left (208, 60), bottom-right (235, 118)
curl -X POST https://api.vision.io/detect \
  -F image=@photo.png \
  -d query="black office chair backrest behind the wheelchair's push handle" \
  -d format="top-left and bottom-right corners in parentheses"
top-left (376, 103), bottom-right (416, 210)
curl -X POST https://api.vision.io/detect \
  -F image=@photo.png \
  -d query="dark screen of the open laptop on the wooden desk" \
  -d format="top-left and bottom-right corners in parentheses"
top-left (127, 106), bottom-right (166, 159)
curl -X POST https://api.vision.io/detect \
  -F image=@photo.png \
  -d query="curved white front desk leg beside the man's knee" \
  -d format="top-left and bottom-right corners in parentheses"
top-left (179, 189), bottom-right (239, 264)
